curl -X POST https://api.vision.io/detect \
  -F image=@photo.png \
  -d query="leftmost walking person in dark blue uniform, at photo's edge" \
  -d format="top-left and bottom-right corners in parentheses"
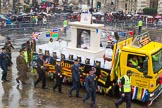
top-left (0, 48), bottom-right (8, 81)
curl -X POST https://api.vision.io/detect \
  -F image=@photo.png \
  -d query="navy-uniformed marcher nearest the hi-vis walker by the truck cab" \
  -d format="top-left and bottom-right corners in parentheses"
top-left (83, 68), bottom-right (96, 108)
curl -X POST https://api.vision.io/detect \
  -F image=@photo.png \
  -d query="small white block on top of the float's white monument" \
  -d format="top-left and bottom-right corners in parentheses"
top-left (80, 13), bottom-right (92, 24)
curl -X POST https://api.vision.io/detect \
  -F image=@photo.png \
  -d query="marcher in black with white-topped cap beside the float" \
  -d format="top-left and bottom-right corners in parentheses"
top-left (53, 59), bottom-right (63, 93)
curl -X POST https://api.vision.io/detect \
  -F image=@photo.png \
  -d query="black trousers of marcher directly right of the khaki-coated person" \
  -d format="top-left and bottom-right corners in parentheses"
top-left (35, 71), bottom-right (46, 88)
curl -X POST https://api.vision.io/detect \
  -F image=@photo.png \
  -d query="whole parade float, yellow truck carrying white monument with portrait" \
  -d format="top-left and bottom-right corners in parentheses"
top-left (31, 14), bottom-right (162, 105)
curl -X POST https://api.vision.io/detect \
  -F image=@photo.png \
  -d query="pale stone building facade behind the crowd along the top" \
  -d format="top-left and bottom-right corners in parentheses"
top-left (17, 0), bottom-right (162, 14)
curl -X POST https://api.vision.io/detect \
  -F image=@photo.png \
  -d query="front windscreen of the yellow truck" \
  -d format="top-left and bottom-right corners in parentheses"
top-left (152, 49), bottom-right (162, 73)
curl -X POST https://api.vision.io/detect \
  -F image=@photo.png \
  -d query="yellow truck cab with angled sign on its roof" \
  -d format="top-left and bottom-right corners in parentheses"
top-left (111, 33), bottom-right (162, 105)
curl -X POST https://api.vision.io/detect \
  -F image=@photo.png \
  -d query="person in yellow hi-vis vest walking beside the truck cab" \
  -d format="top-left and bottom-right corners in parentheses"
top-left (115, 70), bottom-right (132, 108)
